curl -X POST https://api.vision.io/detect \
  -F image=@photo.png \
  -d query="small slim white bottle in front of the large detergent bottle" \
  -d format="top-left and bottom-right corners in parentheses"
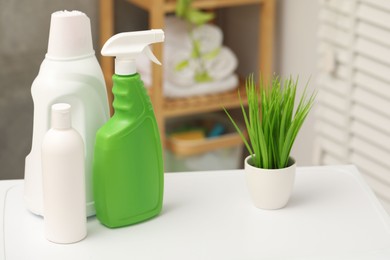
top-left (42, 103), bottom-right (87, 244)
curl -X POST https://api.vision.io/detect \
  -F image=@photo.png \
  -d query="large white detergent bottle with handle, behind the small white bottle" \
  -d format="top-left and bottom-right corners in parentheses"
top-left (24, 11), bottom-right (109, 216)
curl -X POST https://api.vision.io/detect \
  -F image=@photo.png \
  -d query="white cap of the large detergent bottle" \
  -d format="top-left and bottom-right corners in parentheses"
top-left (46, 11), bottom-right (95, 60)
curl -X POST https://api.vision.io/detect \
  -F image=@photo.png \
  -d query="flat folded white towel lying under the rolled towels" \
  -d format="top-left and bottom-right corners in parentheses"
top-left (164, 74), bottom-right (239, 98)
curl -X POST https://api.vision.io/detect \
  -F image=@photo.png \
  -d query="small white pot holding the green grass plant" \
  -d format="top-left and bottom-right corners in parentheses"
top-left (245, 156), bottom-right (296, 209)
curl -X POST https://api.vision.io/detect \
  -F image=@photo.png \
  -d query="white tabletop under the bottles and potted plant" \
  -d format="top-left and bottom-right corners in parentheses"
top-left (0, 166), bottom-right (390, 260)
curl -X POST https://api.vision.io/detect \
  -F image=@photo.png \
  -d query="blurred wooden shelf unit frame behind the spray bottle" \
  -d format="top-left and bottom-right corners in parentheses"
top-left (100, 0), bottom-right (275, 144)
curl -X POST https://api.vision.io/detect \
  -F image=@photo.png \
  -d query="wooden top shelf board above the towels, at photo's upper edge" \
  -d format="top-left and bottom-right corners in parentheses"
top-left (127, 0), bottom-right (265, 13)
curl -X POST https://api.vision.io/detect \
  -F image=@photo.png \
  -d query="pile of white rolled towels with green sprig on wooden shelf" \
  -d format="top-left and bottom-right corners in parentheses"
top-left (136, 17), bottom-right (238, 97)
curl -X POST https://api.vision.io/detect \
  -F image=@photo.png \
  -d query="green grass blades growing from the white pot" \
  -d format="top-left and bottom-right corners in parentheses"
top-left (225, 75), bottom-right (315, 169)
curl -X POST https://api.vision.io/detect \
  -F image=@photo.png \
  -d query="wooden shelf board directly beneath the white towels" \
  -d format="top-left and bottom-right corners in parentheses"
top-left (163, 82), bottom-right (247, 118)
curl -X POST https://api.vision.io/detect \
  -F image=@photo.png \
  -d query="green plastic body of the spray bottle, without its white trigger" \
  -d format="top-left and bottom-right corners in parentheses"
top-left (93, 74), bottom-right (164, 227)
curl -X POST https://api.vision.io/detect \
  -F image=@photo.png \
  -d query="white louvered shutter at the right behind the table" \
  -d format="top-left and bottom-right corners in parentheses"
top-left (315, 0), bottom-right (390, 212)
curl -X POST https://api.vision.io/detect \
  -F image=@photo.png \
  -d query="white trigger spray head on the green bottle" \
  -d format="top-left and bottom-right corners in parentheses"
top-left (101, 29), bottom-right (164, 75)
